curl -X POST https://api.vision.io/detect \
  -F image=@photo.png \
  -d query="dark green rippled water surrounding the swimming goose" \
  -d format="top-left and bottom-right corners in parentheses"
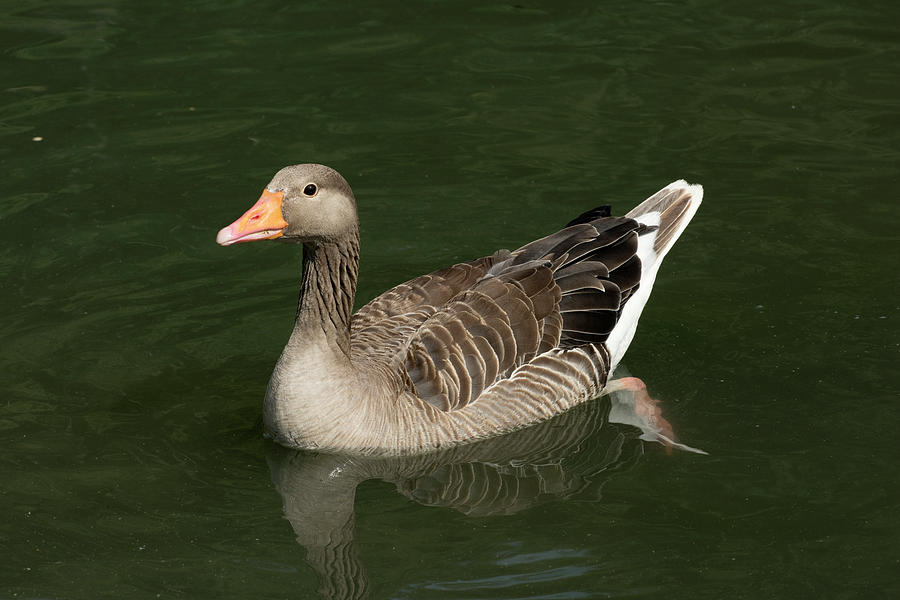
top-left (0, 0), bottom-right (900, 599)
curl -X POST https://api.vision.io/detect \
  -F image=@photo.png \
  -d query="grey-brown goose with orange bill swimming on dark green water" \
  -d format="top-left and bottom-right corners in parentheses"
top-left (216, 164), bottom-right (703, 455)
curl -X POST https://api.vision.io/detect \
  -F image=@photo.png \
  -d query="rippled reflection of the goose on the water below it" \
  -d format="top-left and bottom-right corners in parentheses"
top-left (267, 382), bottom-right (704, 599)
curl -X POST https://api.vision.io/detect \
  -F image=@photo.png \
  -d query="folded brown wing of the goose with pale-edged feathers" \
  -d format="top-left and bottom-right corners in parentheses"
top-left (352, 206), bottom-right (649, 411)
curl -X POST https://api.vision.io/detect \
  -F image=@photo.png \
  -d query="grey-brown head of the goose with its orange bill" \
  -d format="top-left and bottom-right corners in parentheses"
top-left (216, 164), bottom-right (359, 246)
